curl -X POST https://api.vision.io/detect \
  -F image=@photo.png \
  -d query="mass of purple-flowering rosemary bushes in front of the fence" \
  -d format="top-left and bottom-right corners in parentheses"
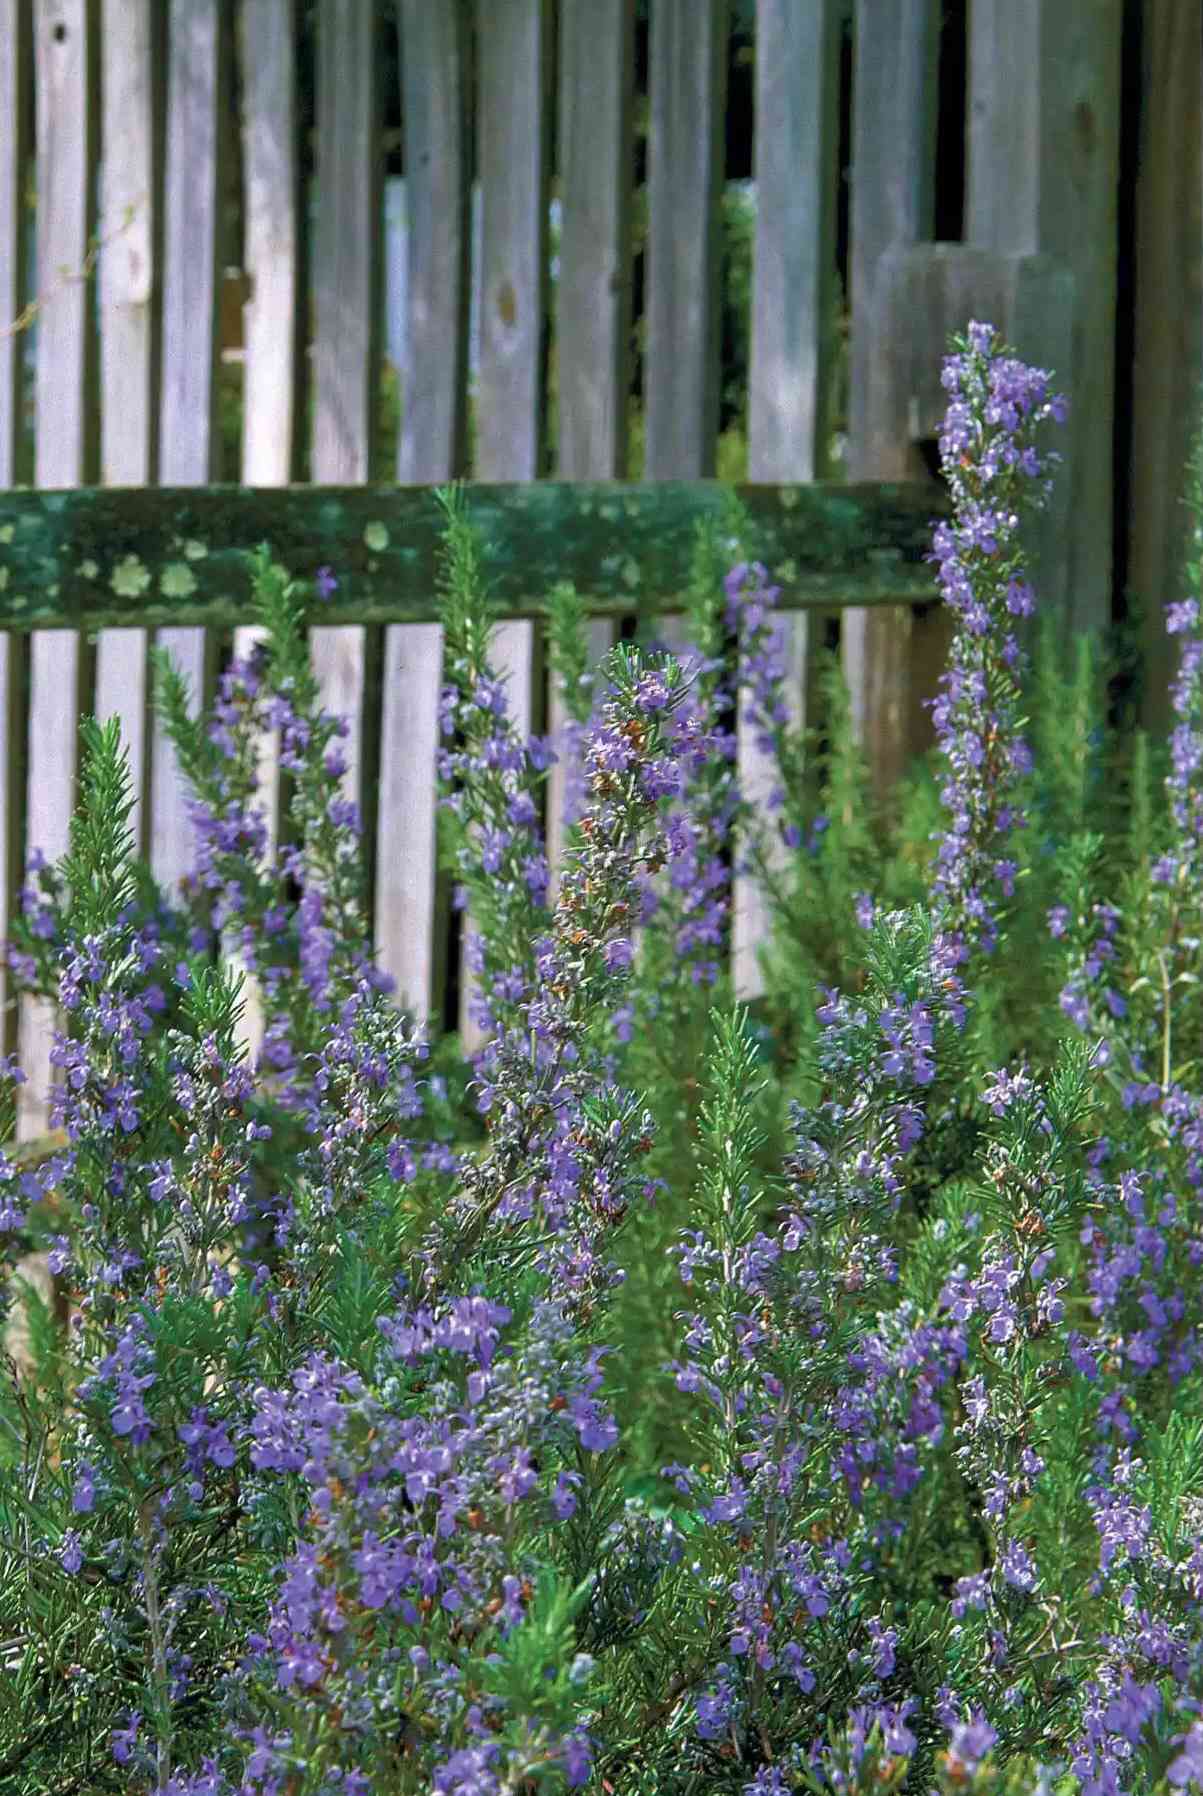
top-left (0, 325), bottom-right (1203, 1796)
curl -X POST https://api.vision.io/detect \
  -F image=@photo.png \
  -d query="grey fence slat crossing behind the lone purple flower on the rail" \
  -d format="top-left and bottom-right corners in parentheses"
top-left (311, 0), bottom-right (381, 840)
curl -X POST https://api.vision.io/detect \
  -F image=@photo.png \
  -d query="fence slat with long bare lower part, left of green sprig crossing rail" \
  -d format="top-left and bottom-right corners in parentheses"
top-left (375, 0), bottom-right (472, 1017)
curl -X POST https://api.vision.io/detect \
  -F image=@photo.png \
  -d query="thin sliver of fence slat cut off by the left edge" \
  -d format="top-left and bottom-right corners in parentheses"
top-left (0, 0), bottom-right (31, 1054)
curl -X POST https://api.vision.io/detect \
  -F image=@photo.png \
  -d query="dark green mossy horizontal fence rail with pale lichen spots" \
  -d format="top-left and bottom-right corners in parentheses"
top-left (0, 481), bottom-right (944, 632)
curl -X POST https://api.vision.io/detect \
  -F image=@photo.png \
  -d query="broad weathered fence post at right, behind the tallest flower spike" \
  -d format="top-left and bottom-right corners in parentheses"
top-left (966, 0), bottom-right (1127, 629)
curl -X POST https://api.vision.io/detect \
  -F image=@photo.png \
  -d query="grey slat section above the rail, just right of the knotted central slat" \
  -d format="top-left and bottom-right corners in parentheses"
top-left (557, 0), bottom-right (636, 480)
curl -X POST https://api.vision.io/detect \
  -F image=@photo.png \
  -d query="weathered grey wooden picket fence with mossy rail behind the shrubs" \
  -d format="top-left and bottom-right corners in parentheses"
top-left (0, 0), bottom-right (1203, 1135)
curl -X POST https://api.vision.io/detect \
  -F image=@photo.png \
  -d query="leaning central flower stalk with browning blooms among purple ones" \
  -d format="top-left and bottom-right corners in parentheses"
top-left (427, 632), bottom-right (706, 1307)
